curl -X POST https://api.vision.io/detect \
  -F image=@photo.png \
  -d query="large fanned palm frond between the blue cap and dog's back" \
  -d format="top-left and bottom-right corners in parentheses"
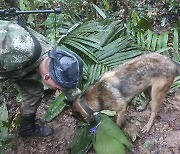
top-left (59, 20), bottom-right (143, 89)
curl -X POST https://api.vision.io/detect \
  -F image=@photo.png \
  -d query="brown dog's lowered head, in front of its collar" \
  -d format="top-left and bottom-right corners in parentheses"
top-left (73, 96), bottom-right (94, 123)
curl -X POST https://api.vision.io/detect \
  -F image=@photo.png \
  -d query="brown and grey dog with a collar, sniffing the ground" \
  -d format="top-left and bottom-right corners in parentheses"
top-left (73, 53), bottom-right (180, 132)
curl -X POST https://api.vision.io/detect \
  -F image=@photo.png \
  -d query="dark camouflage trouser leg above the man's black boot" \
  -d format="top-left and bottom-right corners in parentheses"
top-left (15, 80), bottom-right (44, 115)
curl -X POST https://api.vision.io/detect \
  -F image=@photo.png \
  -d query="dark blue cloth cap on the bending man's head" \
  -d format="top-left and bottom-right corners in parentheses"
top-left (48, 48), bottom-right (83, 90)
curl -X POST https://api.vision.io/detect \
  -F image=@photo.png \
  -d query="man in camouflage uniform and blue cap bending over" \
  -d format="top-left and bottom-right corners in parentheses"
top-left (0, 20), bottom-right (83, 137)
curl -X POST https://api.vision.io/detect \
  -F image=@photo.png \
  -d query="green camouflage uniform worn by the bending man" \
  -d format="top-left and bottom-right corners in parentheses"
top-left (0, 20), bottom-right (79, 115)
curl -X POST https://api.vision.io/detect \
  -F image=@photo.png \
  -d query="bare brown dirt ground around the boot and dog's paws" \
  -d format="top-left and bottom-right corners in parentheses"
top-left (2, 87), bottom-right (180, 154)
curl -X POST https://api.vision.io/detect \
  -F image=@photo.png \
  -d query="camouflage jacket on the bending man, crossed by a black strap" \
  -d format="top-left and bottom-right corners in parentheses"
top-left (0, 20), bottom-right (53, 80)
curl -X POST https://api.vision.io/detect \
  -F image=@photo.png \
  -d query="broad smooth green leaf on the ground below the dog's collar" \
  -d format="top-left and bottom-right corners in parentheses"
top-left (93, 114), bottom-right (131, 154)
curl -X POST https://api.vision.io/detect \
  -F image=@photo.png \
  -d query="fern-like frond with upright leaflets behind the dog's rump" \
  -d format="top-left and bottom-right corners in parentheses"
top-left (128, 20), bottom-right (180, 90)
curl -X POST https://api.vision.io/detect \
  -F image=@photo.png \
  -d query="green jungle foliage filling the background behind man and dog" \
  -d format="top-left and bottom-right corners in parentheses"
top-left (0, 0), bottom-right (180, 153)
